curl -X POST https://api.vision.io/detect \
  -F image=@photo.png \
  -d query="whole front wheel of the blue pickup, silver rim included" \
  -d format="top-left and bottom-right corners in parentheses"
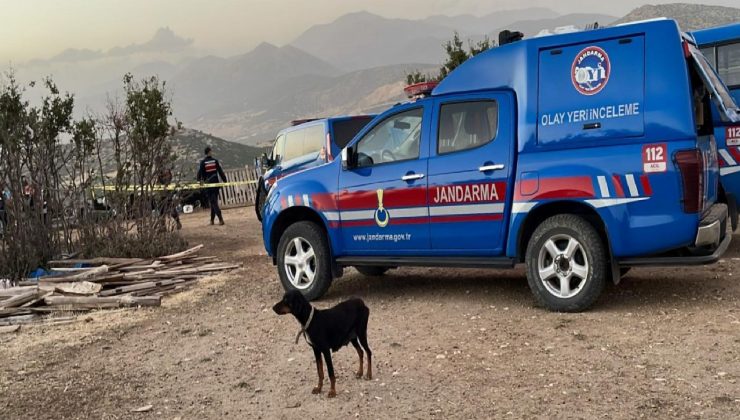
top-left (277, 222), bottom-right (332, 300)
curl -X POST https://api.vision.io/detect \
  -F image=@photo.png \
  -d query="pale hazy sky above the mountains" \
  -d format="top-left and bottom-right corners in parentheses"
top-left (0, 0), bottom-right (737, 64)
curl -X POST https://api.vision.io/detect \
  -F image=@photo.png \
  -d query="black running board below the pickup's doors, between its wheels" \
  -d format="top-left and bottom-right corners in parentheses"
top-left (337, 257), bottom-right (516, 268)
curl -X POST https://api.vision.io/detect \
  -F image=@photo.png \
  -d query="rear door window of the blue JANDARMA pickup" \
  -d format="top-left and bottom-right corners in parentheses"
top-left (437, 101), bottom-right (498, 155)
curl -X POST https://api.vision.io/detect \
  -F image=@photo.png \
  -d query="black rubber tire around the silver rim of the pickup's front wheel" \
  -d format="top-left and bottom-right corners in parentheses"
top-left (277, 222), bottom-right (332, 300)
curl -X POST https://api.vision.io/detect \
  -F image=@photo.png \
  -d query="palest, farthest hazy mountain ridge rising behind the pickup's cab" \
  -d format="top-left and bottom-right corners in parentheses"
top-left (292, 8), bottom-right (617, 70)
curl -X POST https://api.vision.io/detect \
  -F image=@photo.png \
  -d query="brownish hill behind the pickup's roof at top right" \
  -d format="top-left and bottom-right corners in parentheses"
top-left (615, 3), bottom-right (740, 31)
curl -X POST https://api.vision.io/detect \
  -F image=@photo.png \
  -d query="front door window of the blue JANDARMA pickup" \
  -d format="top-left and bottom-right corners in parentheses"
top-left (357, 108), bottom-right (424, 166)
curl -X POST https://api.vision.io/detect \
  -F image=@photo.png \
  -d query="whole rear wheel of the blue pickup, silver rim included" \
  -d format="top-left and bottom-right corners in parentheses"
top-left (526, 214), bottom-right (609, 312)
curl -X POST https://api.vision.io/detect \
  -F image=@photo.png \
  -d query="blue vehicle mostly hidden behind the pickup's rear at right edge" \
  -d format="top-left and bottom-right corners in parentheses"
top-left (692, 23), bottom-right (740, 230)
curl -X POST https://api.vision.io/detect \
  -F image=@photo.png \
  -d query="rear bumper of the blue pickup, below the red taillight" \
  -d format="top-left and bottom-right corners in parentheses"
top-left (618, 203), bottom-right (732, 267)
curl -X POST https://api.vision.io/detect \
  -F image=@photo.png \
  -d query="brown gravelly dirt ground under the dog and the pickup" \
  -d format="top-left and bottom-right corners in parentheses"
top-left (0, 208), bottom-right (740, 419)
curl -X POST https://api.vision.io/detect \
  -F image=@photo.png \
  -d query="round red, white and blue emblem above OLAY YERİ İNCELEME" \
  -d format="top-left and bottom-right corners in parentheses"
top-left (570, 46), bottom-right (612, 95)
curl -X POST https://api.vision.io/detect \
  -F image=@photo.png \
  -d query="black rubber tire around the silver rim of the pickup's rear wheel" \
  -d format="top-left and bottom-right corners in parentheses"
top-left (525, 214), bottom-right (611, 312)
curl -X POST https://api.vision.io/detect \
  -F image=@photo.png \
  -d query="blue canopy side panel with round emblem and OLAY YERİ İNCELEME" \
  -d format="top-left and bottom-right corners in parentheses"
top-left (537, 35), bottom-right (645, 145)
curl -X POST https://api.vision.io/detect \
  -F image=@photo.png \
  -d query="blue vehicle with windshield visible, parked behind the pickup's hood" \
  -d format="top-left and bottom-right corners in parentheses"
top-left (254, 115), bottom-right (375, 221)
